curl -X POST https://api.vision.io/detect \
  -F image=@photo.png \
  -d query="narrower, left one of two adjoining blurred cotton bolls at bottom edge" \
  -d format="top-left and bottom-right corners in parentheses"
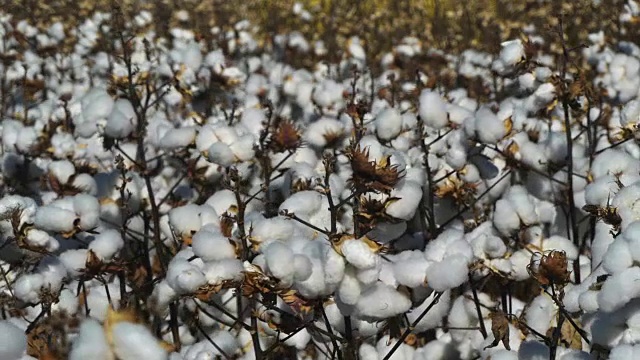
top-left (69, 318), bottom-right (113, 360)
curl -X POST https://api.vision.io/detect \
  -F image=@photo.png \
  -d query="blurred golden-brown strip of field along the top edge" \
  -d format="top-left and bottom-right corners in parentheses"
top-left (3, 0), bottom-right (638, 66)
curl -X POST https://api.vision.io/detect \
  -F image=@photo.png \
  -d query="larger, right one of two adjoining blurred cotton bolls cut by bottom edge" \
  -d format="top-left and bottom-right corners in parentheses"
top-left (111, 322), bottom-right (168, 360)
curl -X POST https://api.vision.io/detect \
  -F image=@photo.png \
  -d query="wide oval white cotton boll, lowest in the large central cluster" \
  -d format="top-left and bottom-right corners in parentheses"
top-left (356, 282), bottom-right (411, 321)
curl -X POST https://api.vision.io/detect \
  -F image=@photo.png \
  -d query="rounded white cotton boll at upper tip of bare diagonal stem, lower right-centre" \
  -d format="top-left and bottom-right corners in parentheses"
top-left (427, 255), bottom-right (469, 291)
